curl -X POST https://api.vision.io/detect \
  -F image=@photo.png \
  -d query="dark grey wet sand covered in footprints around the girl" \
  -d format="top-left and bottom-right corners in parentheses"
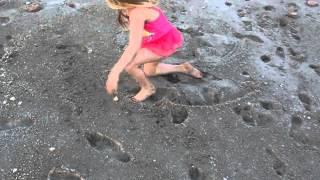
top-left (0, 0), bottom-right (320, 180)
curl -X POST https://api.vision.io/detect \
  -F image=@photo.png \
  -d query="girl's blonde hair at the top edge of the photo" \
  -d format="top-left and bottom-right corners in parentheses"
top-left (106, 0), bottom-right (159, 10)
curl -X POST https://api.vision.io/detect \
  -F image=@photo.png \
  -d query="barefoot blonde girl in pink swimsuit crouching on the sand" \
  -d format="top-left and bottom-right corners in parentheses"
top-left (105, 0), bottom-right (202, 102)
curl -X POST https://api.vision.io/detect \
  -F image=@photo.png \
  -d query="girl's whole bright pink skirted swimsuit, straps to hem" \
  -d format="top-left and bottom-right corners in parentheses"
top-left (141, 7), bottom-right (183, 57)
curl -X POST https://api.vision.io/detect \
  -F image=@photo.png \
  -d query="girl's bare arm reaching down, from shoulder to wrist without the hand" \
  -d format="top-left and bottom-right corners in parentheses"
top-left (112, 8), bottom-right (146, 75)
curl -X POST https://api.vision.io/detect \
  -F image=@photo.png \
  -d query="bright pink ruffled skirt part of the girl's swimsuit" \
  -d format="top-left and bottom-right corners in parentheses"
top-left (141, 28), bottom-right (183, 57)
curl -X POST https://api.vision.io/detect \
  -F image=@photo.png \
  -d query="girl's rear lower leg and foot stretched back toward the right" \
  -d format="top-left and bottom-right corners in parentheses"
top-left (143, 62), bottom-right (202, 78)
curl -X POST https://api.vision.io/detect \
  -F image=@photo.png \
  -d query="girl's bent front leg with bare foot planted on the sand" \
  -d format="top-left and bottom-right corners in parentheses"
top-left (126, 49), bottom-right (161, 102)
